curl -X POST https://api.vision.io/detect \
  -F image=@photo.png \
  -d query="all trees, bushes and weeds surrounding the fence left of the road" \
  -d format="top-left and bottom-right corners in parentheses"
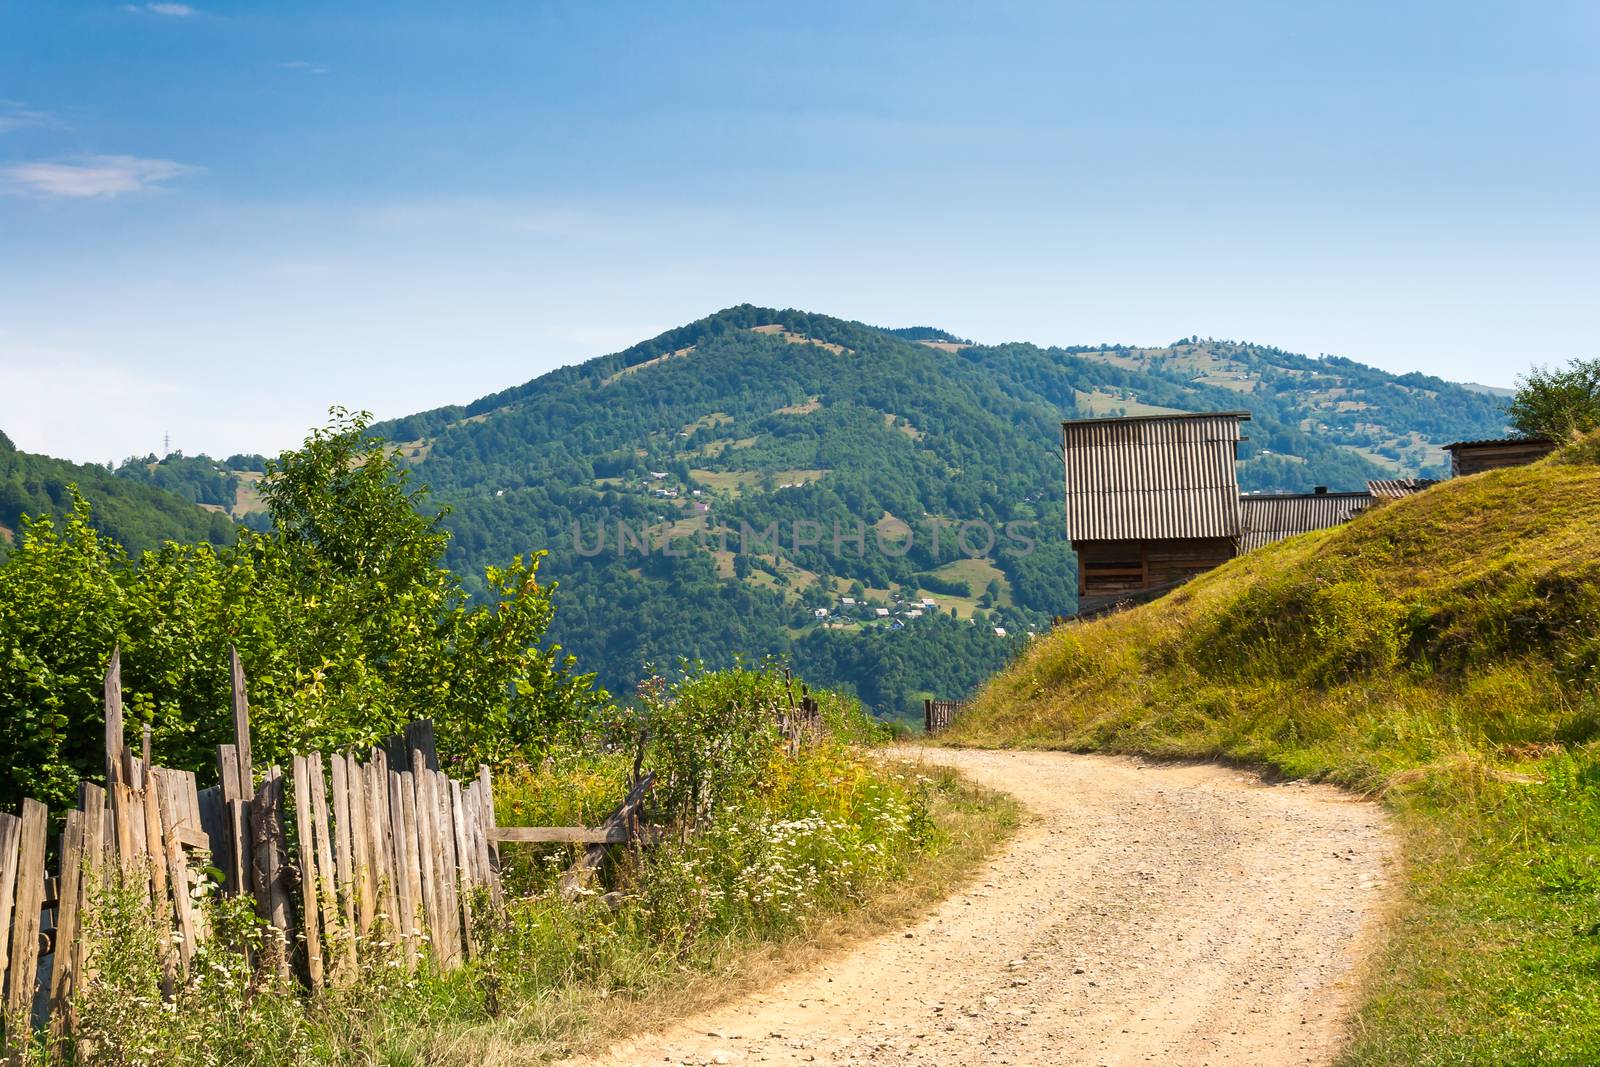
top-left (0, 413), bottom-right (1013, 1064)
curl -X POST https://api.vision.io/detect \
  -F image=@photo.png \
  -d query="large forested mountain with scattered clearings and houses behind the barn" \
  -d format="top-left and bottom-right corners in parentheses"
top-left (340, 306), bottom-right (1504, 712)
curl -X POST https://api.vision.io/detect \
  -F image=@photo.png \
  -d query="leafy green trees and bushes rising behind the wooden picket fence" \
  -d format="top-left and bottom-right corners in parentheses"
top-left (0, 413), bottom-right (605, 806)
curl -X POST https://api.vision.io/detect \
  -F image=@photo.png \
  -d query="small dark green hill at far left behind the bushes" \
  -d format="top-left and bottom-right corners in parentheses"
top-left (0, 434), bottom-right (234, 560)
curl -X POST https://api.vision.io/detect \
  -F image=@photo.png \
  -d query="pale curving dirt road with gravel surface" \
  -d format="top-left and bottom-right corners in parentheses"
top-left (569, 750), bottom-right (1392, 1067)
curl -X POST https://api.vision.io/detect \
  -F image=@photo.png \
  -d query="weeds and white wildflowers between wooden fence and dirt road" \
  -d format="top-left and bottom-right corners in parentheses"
top-left (56, 669), bottom-right (1014, 1065)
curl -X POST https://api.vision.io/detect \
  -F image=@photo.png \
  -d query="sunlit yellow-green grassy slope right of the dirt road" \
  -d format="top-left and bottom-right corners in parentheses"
top-left (952, 450), bottom-right (1600, 1064)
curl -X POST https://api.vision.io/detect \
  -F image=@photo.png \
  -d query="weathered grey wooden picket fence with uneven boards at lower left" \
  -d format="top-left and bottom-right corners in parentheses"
top-left (0, 653), bottom-right (518, 1054)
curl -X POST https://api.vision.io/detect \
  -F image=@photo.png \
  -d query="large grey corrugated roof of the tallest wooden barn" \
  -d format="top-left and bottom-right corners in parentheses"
top-left (1061, 411), bottom-right (1250, 541)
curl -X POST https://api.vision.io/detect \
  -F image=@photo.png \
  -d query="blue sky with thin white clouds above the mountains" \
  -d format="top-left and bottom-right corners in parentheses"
top-left (0, 0), bottom-right (1600, 462)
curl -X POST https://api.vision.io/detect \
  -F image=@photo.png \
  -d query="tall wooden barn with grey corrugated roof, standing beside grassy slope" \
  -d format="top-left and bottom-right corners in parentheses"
top-left (1061, 411), bottom-right (1250, 616)
